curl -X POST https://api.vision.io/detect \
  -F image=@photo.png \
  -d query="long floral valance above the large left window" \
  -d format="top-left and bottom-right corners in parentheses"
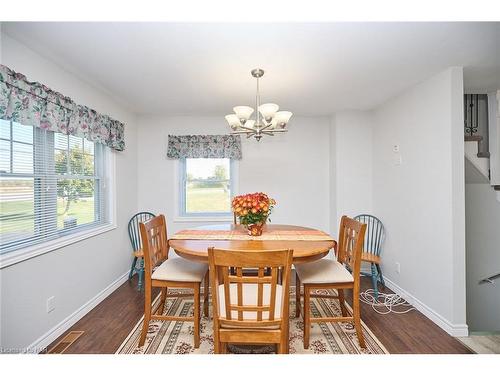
top-left (0, 64), bottom-right (125, 151)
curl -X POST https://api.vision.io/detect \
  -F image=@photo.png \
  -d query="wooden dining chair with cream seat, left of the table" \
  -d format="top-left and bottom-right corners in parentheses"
top-left (139, 215), bottom-right (209, 348)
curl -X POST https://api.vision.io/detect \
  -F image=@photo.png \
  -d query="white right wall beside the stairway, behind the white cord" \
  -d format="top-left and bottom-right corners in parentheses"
top-left (373, 68), bottom-right (466, 335)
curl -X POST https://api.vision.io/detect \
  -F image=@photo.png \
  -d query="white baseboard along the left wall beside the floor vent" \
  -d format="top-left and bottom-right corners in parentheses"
top-left (26, 271), bottom-right (129, 353)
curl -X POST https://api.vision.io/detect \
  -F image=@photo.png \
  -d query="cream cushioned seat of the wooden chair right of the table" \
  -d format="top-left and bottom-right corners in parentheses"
top-left (295, 259), bottom-right (354, 284)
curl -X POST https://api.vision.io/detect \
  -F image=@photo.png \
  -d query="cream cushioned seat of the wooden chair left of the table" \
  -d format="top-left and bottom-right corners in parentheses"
top-left (151, 258), bottom-right (208, 282)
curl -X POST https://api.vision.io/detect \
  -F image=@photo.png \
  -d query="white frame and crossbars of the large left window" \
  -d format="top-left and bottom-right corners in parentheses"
top-left (0, 121), bottom-right (117, 269)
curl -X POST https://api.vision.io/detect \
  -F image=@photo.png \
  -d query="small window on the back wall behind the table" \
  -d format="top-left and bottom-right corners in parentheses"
top-left (179, 158), bottom-right (234, 217)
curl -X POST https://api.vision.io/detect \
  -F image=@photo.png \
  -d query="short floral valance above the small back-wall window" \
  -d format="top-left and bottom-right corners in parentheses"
top-left (167, 135), bottom-right (241, 159)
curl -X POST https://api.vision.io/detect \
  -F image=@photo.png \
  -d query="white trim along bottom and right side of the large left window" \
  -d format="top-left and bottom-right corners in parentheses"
top-left (0, 150), bottom-right (117, 269)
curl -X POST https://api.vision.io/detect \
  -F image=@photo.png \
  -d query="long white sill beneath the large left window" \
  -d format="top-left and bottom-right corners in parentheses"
top-left (0, 224), bottom-right (116, 269)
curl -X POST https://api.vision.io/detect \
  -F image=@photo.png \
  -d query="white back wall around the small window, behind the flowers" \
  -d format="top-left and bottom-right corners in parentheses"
top-left (138, 115), bottom-right (330, 233)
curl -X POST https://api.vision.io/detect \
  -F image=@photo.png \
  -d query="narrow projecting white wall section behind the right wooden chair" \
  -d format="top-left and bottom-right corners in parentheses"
top-left (330, 111), bottom-right (373, 234)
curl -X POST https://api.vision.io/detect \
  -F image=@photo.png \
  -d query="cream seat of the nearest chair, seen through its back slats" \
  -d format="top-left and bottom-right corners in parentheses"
top-left (219, 284), bottom-right (283, 320)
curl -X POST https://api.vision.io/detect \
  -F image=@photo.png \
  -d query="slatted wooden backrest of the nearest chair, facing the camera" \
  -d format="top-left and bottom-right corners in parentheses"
top-left (208, 248), bottom-right (293, 328)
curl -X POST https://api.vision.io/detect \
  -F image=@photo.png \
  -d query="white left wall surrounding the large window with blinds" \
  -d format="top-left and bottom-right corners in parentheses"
top-left (0, 35), bottom-right (137, 348)
